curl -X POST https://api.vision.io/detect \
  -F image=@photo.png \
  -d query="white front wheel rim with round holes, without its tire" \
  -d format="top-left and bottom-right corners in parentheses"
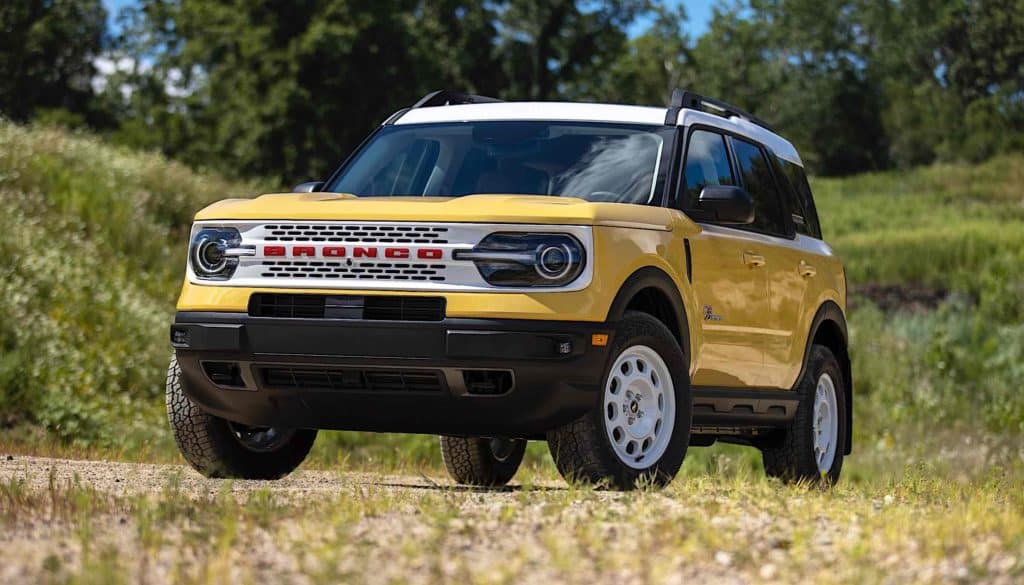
top-left (603, 345), bottom-right (675, 469)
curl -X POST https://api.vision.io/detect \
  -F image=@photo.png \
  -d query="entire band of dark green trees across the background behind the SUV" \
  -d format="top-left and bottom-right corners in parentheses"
top-left (0, 0), bottom-right (1024, 181)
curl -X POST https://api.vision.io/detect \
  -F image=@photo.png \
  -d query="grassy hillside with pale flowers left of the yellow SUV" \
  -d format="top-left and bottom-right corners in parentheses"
top-left (0, 122), bottom-right (268, 445)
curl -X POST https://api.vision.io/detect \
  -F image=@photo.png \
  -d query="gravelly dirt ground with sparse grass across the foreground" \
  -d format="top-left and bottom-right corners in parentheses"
top-left (0, 455), bottom-right (1024, 584)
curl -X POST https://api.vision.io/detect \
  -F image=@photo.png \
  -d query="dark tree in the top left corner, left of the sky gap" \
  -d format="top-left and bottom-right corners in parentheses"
top-left (0, 0), bottom-right (106, 121)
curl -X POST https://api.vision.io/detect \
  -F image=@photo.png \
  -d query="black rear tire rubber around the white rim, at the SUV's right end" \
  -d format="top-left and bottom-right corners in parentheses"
top-left (761, 345), bottom-right (847, 484)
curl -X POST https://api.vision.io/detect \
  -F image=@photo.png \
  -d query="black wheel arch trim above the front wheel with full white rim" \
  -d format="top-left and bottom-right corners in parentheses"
top-left (607, 266), bottom-right (691, 358)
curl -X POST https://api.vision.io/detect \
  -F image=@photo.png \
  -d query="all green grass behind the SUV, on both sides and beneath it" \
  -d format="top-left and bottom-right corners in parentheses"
top-left (0, 122), bottom-right (1024, 476)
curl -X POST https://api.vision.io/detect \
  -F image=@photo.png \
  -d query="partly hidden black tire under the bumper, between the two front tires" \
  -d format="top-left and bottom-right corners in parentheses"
top-left (440, 436), bottom-right (526, 487)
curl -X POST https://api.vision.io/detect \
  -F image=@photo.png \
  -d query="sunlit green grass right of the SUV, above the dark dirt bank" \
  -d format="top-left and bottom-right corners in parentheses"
top-left (813, 155), bottom-right (1024, 296)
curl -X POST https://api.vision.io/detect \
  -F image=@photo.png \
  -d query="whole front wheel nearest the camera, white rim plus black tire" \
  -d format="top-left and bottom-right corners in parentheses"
top-left (548, 311), bottom-right (692, 490)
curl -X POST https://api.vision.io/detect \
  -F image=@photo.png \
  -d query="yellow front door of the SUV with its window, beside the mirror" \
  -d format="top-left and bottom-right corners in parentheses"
top-left (680, 128), bottom-right (768, 388)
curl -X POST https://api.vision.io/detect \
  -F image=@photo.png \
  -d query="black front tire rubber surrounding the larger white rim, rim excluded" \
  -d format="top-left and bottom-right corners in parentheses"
top-left (547, 311), bottom-right (693, 490)
